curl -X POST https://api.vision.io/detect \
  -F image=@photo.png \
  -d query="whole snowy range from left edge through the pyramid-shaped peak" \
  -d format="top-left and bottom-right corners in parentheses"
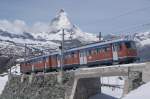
top-left (0, 9), bottom-right (98, 56)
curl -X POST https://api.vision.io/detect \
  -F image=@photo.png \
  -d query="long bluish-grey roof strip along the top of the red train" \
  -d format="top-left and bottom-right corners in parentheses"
top-left (26, 39), bottom-right (133, 61)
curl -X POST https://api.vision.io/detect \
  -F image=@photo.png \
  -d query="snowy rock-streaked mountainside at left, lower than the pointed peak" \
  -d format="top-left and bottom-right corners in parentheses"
top-left (0, 30), bottom-right (58, 56)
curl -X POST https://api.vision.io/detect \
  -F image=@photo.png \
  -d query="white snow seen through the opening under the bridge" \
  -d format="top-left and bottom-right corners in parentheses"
top-left (89, 76), bottom-right (124, 99)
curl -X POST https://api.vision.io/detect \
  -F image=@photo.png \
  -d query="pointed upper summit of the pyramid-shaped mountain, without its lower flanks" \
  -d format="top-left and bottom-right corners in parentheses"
top-left (51, 9), bottom-right (72, 30)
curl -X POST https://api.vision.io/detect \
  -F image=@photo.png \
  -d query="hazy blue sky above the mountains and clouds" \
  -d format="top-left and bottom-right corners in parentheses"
top-left (0, 0), bottom-right (150, 34)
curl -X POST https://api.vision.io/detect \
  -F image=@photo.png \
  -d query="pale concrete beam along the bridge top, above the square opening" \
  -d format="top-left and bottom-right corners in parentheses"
top-left (75, 63), bottom-right (146, 78)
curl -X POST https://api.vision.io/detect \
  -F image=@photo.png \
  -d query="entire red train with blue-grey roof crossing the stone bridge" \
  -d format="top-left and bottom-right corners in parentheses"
top-left (21, 40), bottom-right (137, 73)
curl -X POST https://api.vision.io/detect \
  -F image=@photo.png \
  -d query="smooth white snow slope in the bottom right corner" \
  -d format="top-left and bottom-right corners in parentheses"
top-left (123, 82), bottom-right (150, 99)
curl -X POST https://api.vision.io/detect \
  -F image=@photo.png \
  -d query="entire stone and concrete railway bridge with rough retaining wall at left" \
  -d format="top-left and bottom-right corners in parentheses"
top-left (0, 63), bottom-right (150, 99)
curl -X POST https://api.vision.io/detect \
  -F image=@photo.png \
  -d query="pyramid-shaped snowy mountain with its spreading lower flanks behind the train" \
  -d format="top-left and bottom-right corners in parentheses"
top-left (33, 9), bottom-right (98, 43)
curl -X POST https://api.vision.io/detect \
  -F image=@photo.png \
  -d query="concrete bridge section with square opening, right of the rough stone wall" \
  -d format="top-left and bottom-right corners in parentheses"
top-left (66, 63), bottom-right (147, 99)
